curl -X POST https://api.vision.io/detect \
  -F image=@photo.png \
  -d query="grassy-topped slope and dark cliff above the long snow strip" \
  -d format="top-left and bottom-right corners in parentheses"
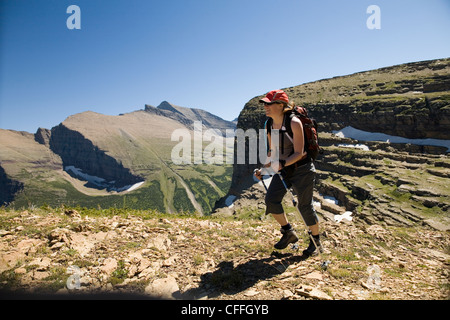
top-left (296, 59), bottom-right (450, 139)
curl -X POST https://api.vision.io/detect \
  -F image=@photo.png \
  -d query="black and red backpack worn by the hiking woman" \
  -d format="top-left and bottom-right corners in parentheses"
top-left (265, 106), bottom-right (323, 160)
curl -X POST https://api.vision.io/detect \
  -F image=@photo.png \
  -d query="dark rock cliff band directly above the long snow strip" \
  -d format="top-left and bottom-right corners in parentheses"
top-left (304, 94), bottom-right (450, 140)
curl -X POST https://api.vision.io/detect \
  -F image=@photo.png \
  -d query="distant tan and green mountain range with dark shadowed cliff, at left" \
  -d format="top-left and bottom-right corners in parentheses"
top-left (0, 102), bottom-right (234, 213)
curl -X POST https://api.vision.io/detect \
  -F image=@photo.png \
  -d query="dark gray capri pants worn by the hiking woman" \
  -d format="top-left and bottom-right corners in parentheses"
top-left (265, 162), bottom-right (319, 226)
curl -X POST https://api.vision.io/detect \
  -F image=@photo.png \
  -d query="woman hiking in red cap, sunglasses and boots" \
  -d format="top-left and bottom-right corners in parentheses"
top-left (255, 90), bottom-right (321, 257)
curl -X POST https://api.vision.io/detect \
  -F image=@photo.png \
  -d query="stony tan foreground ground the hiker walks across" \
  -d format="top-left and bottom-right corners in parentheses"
top-left (0, 208), bottom-right (450, 300)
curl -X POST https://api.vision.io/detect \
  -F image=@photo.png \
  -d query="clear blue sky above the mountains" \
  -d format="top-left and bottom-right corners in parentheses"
top-left (0, 0), bottom-right (450, 133)
